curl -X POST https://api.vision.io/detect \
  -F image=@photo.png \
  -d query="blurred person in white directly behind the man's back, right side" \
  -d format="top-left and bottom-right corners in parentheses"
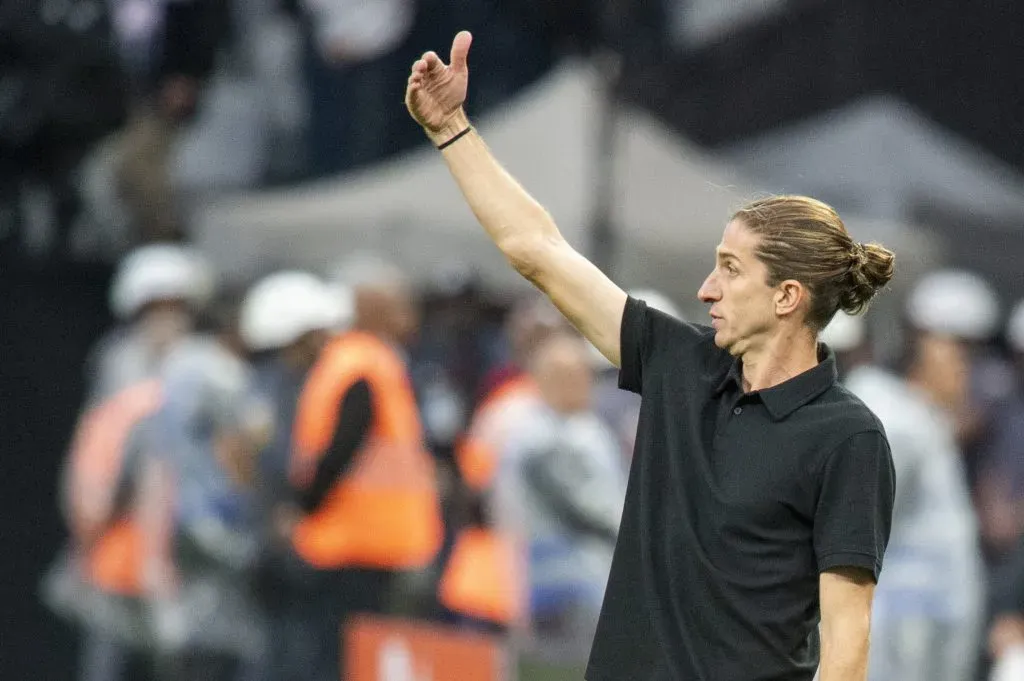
top-left (821, 312), bottom-right (985, 681)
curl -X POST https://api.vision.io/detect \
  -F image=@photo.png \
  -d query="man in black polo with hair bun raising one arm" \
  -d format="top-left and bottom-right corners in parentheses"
top-left (406, 33), bottom-right (895, 681)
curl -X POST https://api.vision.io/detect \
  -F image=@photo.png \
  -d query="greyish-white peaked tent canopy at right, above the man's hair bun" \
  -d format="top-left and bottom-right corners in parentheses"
top-left (723, 96), bottom-right (1024, 220)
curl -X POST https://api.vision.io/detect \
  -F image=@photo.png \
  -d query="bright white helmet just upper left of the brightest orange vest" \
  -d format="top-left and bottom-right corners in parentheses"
top-left (239, 271), bottom-right (345, 350)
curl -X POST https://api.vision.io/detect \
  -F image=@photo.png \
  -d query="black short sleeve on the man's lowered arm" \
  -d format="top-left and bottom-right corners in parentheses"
top-left (814, 430), bottom-right (896, 580)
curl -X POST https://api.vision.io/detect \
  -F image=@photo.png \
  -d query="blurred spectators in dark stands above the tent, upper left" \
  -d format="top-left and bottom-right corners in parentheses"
top-left (0, 0), bottom-right (665, 260)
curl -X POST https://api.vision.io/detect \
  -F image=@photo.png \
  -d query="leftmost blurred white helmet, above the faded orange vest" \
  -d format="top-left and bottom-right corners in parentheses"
top-left (110, 244), bottom-right (213, 320)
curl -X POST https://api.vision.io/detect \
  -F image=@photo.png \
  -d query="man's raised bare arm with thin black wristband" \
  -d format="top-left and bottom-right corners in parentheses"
top-left (406, 31), bottom-right (626, 367)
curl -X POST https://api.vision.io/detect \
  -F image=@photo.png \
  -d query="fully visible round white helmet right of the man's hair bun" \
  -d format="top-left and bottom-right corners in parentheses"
top-left (906, 269), bottom-right (999, 340)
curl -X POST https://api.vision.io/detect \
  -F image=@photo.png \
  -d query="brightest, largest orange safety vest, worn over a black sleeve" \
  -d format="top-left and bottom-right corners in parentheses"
top-left (292, 332), bottom-right (443, 569)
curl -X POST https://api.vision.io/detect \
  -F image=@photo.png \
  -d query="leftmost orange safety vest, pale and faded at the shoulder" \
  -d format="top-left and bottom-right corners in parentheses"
top-left (67, 380), bottom-right (163, 596)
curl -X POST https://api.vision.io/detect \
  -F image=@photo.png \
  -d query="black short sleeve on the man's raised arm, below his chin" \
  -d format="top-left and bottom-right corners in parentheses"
top-left (618, 297), bottom-right (710, 394)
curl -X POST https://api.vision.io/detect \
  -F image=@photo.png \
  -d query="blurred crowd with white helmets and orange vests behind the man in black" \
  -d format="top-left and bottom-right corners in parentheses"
top-left (44, 238), bottom-right (1024, 681)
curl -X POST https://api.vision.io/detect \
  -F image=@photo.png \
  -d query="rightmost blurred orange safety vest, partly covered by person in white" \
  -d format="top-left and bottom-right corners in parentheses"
top-left (437, 376), bottom-right (538, 626)
